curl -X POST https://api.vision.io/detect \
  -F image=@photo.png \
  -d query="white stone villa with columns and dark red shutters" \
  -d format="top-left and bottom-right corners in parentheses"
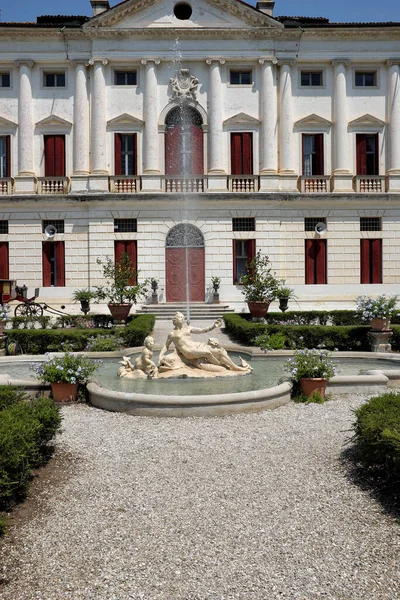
top-left (0, 0), bottom-right (400, 310)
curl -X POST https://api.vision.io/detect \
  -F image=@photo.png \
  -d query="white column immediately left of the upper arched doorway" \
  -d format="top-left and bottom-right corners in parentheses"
top-left (141, 59), bottom-right (160, 175)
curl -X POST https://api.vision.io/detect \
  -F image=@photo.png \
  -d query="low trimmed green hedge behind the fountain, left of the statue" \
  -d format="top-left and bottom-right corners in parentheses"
top-left (7, 315), bottom-right (155, 354)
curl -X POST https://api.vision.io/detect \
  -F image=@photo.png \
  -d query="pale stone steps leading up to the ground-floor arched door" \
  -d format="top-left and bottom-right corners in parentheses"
top-left (136, 302), bottom-right (233, 321)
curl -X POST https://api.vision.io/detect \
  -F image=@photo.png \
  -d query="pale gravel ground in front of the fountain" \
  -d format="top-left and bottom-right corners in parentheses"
top-left (0, 396), bottom-right (400, 600)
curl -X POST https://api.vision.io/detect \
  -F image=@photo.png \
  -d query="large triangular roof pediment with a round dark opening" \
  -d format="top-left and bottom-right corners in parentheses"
top-left (83, 0), bottom-right (283, 30)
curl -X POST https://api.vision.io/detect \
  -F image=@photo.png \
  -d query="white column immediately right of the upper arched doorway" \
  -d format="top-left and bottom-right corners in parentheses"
top-left (206, 58), bottom-right (225, 175)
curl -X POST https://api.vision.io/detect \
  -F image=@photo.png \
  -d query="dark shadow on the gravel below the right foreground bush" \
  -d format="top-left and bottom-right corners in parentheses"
top-left (341, 445), bottom-right (400, 522)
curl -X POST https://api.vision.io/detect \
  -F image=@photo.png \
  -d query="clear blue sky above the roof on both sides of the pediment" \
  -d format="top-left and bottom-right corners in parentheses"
top-left (0, 0), bottom-right (400, 22)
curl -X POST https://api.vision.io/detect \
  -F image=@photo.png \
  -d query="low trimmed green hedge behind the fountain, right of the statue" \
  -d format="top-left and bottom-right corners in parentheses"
top-left (224, 314), bottom-right (372, 351)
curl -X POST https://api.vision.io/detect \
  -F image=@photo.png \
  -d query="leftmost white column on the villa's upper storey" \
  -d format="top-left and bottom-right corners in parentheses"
top-left (15, 60), bottom-right (35, 175)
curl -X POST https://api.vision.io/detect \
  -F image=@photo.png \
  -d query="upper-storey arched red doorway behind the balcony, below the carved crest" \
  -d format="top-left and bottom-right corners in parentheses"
top-left (165, 104), bottom-right (204, 177)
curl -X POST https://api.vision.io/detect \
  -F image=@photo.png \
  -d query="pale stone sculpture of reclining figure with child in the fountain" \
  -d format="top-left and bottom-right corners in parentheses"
top-left (118, 312), bottom-right (253, 379)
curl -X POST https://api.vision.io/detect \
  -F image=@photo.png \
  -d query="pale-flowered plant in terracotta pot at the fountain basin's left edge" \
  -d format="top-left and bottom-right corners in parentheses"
top-left (31, 351), bottom-right (100, 402)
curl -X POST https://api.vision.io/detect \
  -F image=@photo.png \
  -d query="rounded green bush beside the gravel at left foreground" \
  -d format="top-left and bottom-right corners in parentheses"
top-left (0, 397), bottom-right (61, 510)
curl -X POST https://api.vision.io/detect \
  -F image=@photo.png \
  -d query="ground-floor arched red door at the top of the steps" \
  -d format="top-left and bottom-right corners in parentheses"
top-left (165, 223), bottom-right (205, 302)
